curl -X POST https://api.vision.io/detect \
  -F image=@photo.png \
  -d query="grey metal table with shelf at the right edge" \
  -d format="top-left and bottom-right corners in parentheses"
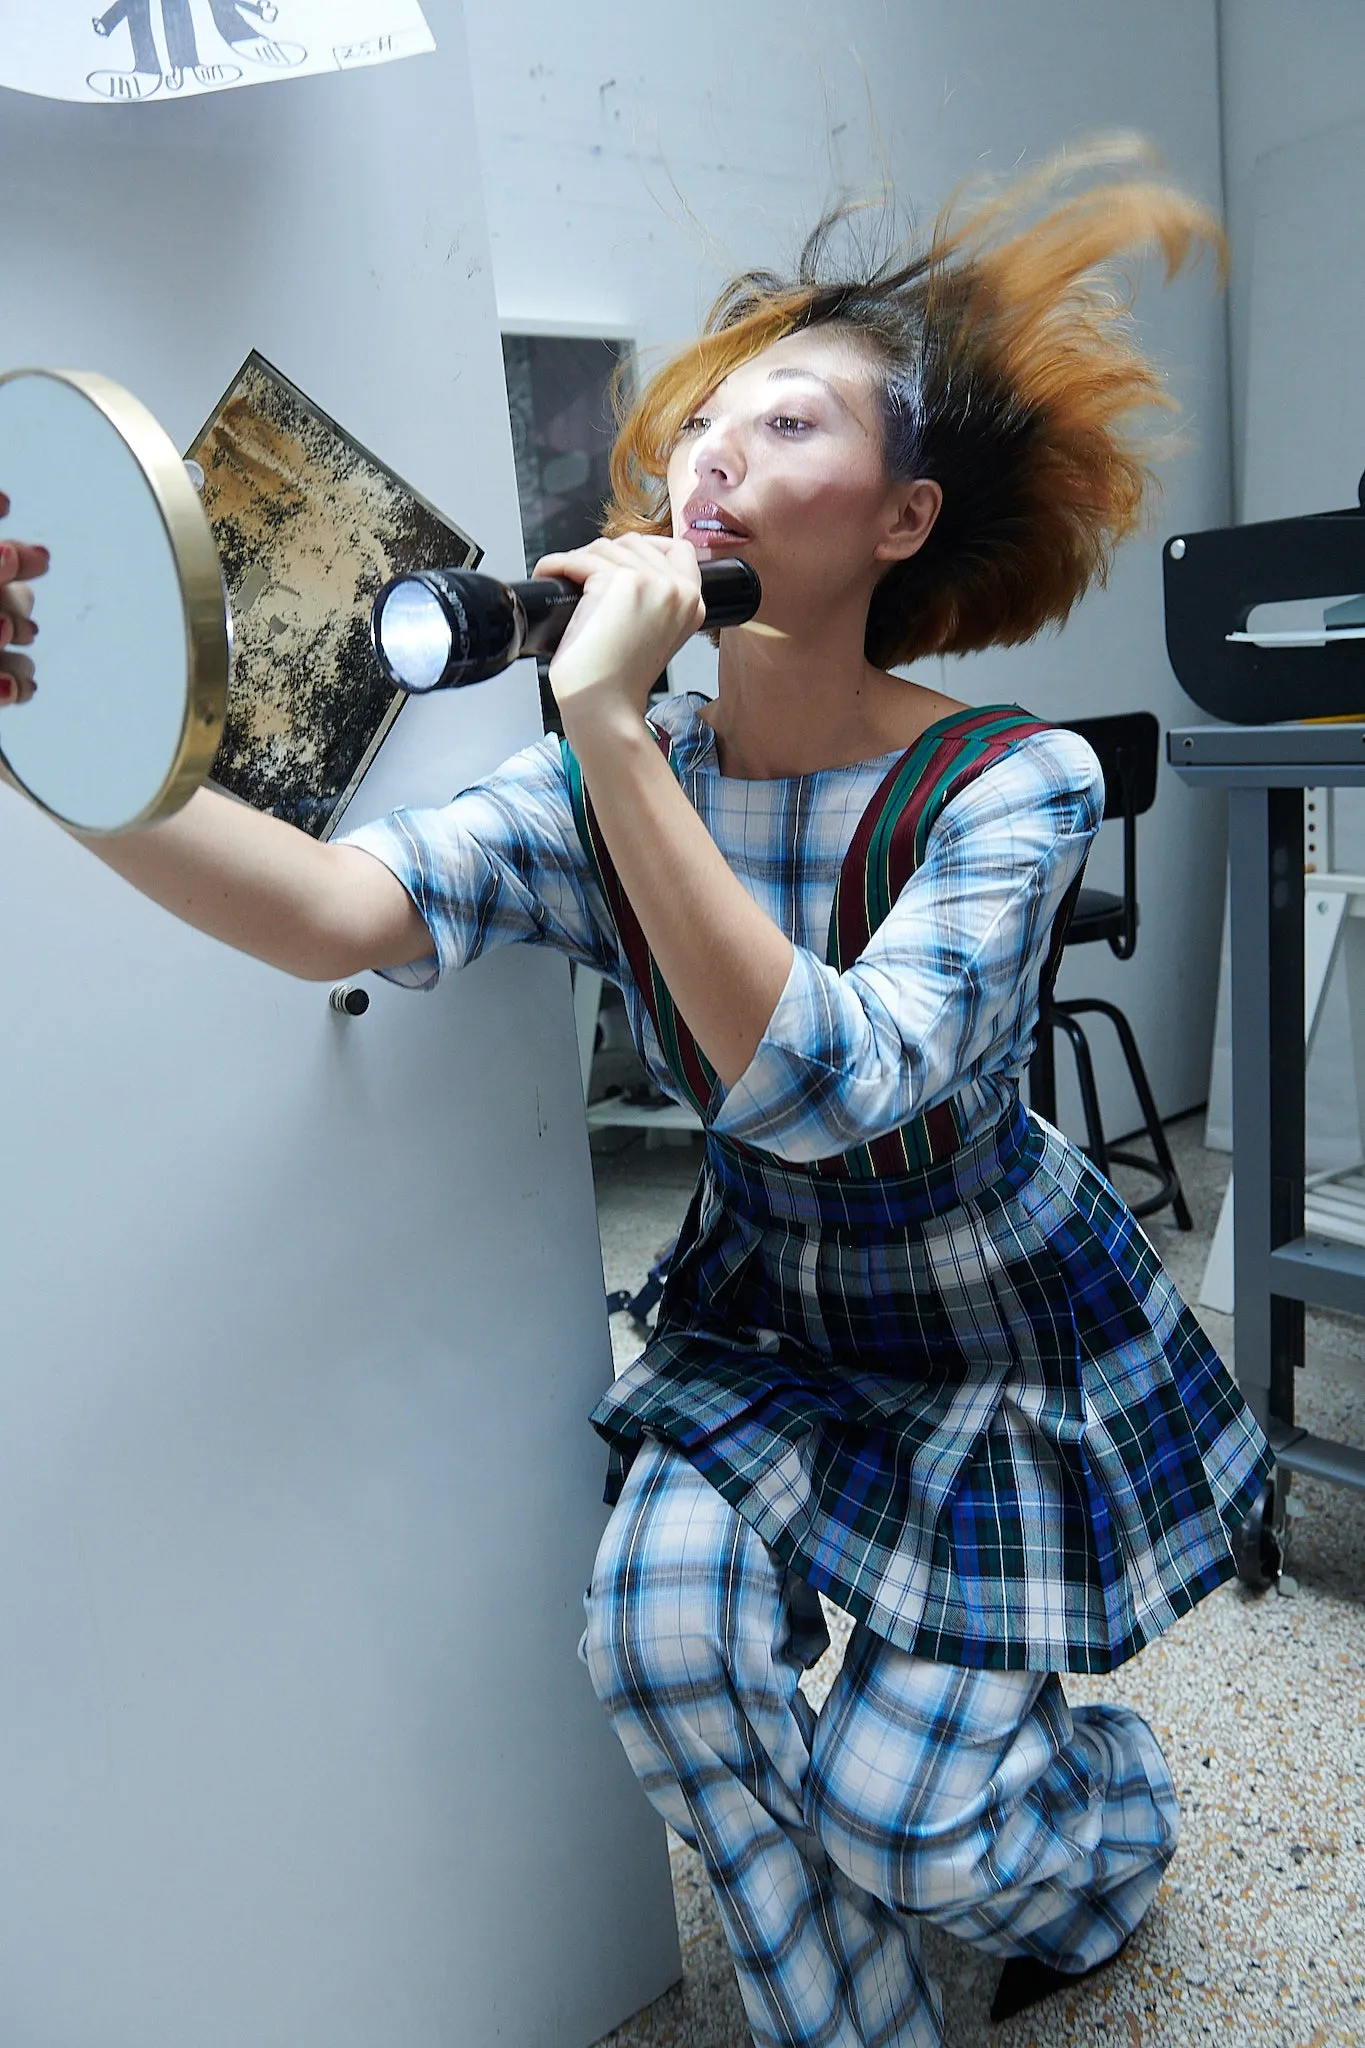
top-left (1166, 723), bottom-right (1365, 1577)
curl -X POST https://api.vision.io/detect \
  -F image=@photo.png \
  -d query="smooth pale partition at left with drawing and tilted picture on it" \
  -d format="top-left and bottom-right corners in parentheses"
top-left (0, 0), bottom-right (677, 2048)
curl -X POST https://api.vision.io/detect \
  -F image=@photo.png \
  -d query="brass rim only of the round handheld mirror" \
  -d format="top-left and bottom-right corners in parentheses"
top-left (0, 369), bottom-right (231, 840)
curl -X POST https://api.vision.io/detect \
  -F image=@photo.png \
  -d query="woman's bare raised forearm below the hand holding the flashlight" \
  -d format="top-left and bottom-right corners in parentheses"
top-left (571, 709), bottom-right (794, 1087)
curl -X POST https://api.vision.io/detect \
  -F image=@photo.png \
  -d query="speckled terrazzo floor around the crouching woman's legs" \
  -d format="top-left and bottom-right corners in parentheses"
top-left (596, 1118), bottom-right (1365, 2048)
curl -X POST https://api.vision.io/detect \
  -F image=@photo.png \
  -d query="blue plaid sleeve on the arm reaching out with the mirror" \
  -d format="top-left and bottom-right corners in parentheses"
top-left (340, 735), bottom-right (616, 989)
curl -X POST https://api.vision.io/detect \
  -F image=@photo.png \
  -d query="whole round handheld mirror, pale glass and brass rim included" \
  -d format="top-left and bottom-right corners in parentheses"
top-left (0, 371), bottom-right (229, 831)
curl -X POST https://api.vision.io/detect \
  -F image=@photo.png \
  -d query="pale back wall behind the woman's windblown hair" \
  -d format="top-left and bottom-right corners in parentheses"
top-left (469, 0), bottom-right (1228, 1130)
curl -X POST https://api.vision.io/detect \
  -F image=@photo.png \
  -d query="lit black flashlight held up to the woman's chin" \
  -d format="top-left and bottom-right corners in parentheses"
top-left (370, 561), bottom-right (763, 696)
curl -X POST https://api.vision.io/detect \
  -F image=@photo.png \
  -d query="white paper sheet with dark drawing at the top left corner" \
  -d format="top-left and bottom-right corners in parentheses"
top-left (0, 0), bottom-right (436, 104)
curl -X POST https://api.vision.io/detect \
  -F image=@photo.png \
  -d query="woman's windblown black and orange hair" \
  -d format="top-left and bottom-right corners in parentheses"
top-left (604, 139), bottom-right (1226, 668)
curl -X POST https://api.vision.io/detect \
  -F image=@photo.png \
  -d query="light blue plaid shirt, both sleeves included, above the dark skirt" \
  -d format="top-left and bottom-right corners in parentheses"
top-left (346, 696), bottom-right (1103, 1161)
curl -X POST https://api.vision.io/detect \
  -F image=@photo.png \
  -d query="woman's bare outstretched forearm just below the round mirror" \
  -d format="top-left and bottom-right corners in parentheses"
top-left (62, 788), bottom-right (432, 981)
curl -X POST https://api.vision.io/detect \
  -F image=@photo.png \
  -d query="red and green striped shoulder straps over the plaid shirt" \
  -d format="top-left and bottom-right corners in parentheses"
top-left (561, 705), bottom-right (1046, 1180)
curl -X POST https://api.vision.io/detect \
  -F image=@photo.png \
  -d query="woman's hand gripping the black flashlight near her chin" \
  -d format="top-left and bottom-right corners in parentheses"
top-left (534, 532), bottom-right (706, 739)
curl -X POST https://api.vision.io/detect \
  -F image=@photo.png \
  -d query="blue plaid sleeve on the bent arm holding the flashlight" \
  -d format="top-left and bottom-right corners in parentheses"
top-left (714, 731), bottom-right (1103, 1161)
